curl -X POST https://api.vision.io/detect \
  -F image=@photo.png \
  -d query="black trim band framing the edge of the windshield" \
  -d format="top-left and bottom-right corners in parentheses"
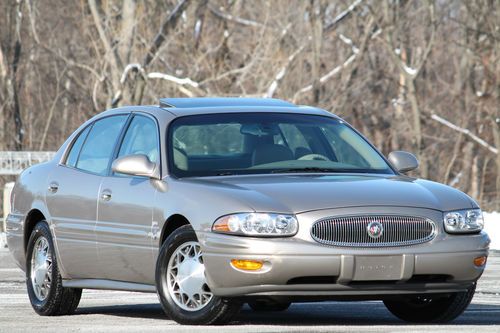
top-left (165, 110), bottom-right (400, 179)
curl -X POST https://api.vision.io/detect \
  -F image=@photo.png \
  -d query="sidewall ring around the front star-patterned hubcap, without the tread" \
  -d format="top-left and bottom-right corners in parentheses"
top-left (156, 225), bottom-right (228, 324)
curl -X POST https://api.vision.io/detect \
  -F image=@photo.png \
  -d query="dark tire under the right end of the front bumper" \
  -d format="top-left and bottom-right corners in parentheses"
top-left (384, 284), bottom-right (476, 323)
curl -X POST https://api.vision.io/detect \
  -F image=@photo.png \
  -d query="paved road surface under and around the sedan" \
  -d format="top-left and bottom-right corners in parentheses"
top-left (0, 249), bottom-right (500, 333)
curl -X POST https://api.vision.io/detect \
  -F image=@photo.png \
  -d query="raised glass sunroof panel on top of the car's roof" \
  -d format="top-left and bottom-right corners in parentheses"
top-left (160, 97), bottom-right (296, 108)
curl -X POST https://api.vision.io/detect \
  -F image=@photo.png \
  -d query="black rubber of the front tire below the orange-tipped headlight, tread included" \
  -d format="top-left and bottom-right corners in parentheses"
top-left (156, 225), bottom-right (242, 325)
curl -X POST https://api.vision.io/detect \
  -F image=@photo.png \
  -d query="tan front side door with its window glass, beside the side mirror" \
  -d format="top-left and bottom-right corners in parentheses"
top-left (96, 114), bottom-right (160, 284)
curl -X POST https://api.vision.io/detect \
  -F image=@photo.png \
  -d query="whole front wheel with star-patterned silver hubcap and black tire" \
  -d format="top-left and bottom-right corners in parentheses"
top-left (156, 225), bottom-right (241, 325)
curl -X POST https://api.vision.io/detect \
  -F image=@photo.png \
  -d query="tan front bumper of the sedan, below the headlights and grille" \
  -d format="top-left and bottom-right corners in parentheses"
top-left (198, 209), bottom-right (489, 298)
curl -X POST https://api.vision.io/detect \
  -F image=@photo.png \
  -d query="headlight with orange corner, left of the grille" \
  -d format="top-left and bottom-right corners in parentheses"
top-left (212, 213), bottom-right (298, 237)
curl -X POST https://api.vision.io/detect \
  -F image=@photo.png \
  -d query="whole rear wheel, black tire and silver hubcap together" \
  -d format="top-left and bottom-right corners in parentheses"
top-left (26, 221), bottom-right (82, 316)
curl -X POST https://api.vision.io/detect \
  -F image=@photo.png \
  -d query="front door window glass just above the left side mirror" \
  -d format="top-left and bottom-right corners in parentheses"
top-left (118, 116), bottom-right (159, 163)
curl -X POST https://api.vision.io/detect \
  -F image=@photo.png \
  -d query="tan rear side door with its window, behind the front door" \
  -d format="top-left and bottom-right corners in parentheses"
top-left (45, 114), bottom-right (128, 278)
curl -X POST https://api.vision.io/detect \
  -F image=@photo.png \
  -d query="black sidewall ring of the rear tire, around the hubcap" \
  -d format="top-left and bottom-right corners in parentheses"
top-left (26, 221), bottom-right (58, 314)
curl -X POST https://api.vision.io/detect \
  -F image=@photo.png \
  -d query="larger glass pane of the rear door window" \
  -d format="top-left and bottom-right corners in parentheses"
top-left (76, 115), bottom-right (128, 175)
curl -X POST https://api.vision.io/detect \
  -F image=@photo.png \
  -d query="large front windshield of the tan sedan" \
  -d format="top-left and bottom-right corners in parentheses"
top-left (169, 113), bottom-right (393, 177)
